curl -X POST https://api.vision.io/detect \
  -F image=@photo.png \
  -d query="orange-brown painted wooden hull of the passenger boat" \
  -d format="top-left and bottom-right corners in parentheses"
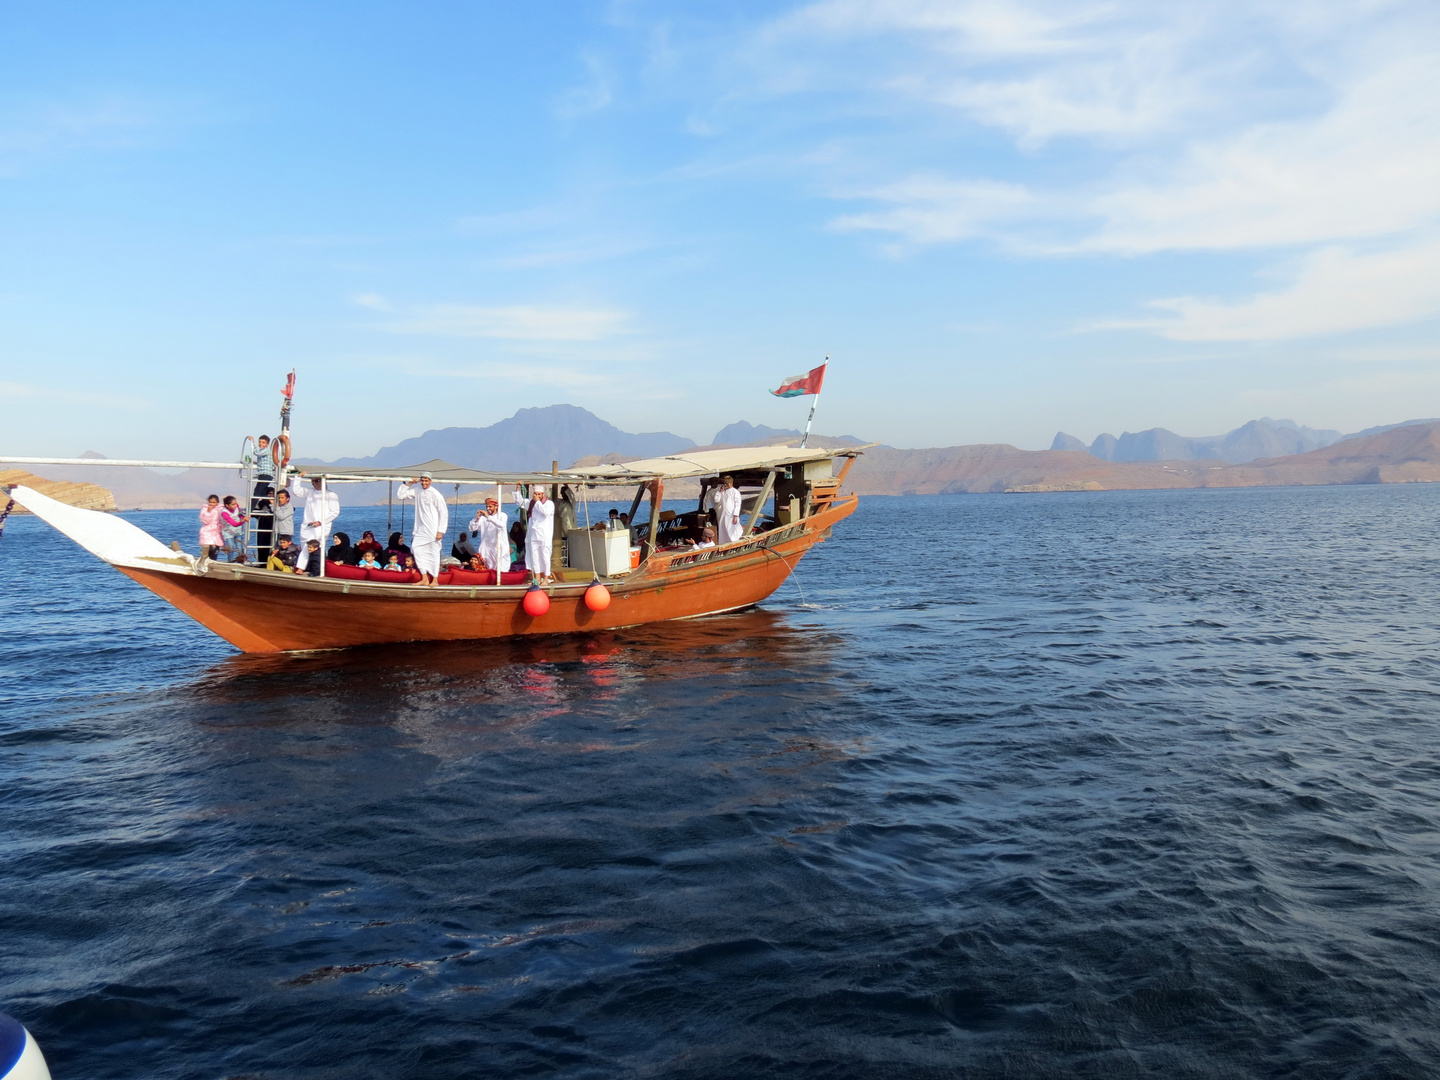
top-left (117, 497), bottom-right (857, 652)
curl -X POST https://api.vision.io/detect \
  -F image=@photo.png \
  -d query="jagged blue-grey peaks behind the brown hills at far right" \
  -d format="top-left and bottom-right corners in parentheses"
top-left (1050, 416), bottom-right (1434, 465)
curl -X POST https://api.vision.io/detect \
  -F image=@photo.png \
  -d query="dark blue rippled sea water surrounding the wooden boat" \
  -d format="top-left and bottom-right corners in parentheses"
top-left (0, 485), bottom-right (1440, 1080)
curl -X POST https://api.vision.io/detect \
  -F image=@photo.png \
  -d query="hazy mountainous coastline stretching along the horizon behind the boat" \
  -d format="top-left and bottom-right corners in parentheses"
top-left (8, 405), bottom-right (1440, 510)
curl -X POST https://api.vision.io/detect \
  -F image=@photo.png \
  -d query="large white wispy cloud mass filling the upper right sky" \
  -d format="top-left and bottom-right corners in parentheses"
top-left (696, 0), bottom-right (1440, 341)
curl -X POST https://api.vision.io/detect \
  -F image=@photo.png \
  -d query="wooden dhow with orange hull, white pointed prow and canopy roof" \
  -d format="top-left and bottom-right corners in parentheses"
top-left (9, 446), bottom-right (865, 652)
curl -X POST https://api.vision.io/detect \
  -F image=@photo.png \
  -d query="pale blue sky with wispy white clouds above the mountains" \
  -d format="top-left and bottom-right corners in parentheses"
top-left (0, 0), bottom-right (1440, 458)
